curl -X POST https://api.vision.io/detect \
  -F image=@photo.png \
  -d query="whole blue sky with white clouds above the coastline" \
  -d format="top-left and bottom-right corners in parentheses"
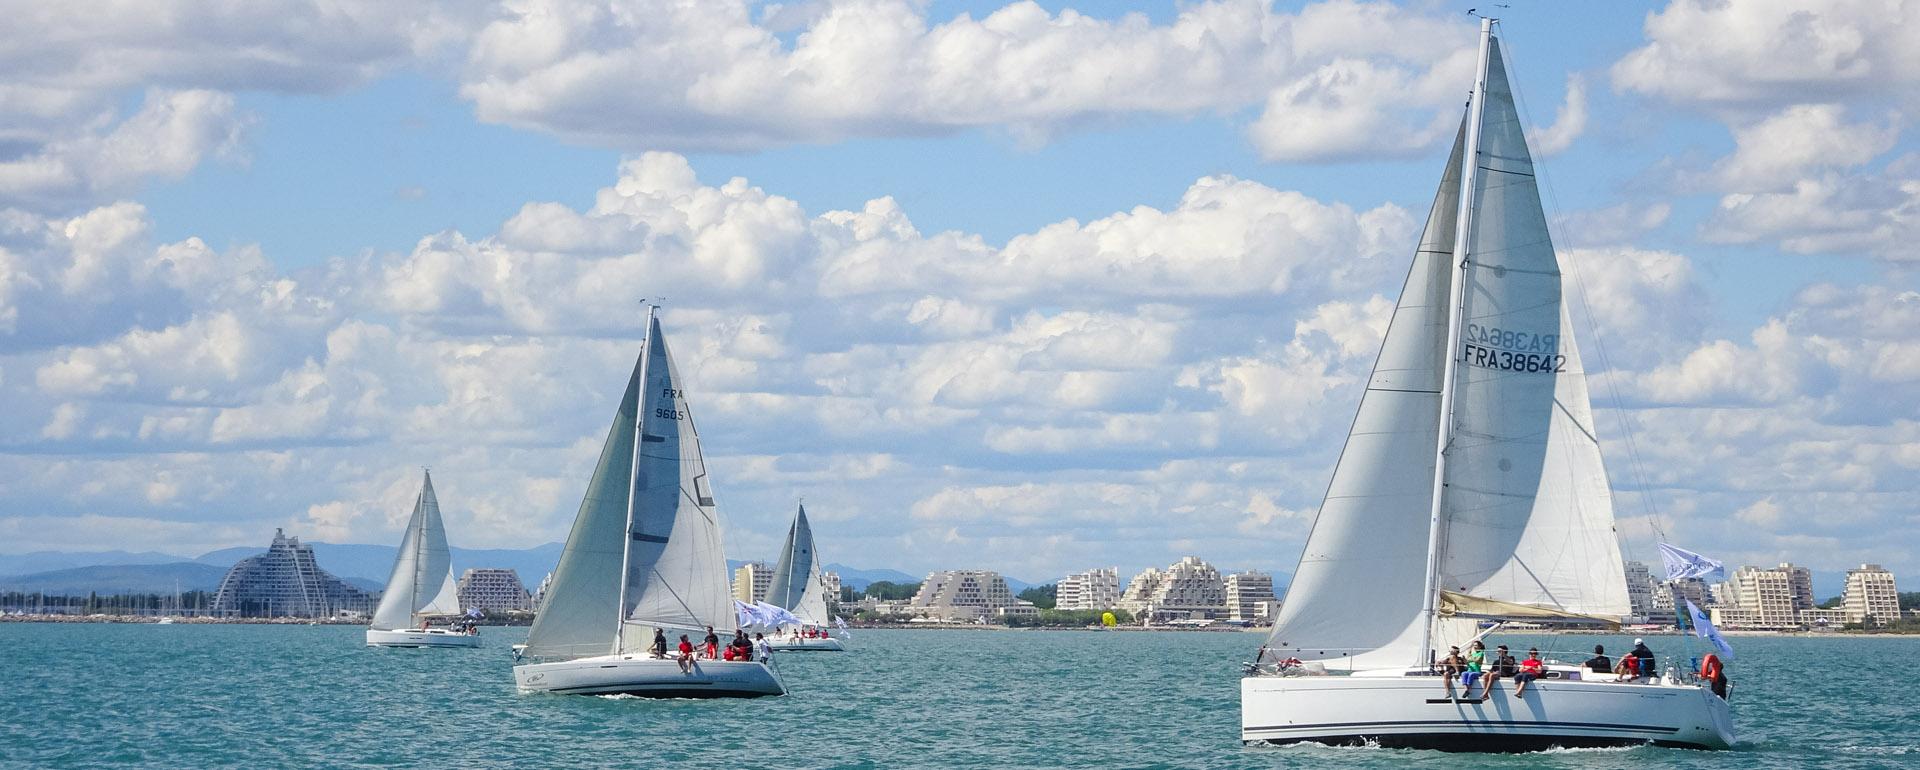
top-left (0, 0), bottom-right (1920, 580)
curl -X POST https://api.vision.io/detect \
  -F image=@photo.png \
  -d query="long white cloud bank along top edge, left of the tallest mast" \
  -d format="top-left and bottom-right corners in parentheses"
top-left (461, 0), bottom-right (1473, 159)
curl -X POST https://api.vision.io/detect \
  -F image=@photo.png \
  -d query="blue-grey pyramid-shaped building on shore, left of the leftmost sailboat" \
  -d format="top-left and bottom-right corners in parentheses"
top-left (211, 530), bottom-right (376, 618)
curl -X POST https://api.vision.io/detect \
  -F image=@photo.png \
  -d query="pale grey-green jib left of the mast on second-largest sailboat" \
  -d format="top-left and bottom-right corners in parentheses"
top-left (524, 353), bottom-right (645, 659)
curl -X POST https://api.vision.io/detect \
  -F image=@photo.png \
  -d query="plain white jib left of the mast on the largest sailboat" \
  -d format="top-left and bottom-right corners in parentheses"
top-left (1267, 118), bottom-right (1465, 666)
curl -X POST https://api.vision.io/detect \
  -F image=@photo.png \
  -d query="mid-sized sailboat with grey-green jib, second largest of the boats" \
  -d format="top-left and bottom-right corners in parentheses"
top-left (513, 307), bottom-right (787, 697)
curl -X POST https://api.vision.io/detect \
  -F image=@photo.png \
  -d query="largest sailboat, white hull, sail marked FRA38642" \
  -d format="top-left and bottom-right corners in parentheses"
top-left (1240, 19), bottom-right (1734, 751)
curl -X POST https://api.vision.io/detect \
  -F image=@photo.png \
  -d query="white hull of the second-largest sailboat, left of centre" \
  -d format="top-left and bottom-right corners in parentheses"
top-left (513, 655), bottom-right (787, 697)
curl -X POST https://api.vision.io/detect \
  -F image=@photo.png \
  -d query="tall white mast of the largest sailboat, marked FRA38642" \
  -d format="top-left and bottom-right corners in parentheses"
top-left (1413, 17), bottom-right (1494, 666)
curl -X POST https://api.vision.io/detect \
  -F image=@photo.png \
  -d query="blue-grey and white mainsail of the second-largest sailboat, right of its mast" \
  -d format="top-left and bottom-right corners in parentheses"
top-left (624, 311), bottom-right (733, 649)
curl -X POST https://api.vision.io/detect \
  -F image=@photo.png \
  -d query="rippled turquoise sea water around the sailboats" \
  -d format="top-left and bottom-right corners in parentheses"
top-left (0, 624), bottom-right (1920, 770)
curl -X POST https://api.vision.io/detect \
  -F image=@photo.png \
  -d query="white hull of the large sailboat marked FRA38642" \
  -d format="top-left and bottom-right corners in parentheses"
top-left (1240, 672), bottom-right (1734, 751)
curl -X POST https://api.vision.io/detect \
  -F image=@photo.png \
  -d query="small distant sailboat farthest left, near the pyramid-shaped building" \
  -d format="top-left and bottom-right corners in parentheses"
top-left (367, 470), bottom-right (480, 647)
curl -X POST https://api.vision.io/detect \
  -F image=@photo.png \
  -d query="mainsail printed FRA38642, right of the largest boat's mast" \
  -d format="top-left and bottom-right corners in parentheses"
top-left (1438, 40), bottom-right (1628, 633)
